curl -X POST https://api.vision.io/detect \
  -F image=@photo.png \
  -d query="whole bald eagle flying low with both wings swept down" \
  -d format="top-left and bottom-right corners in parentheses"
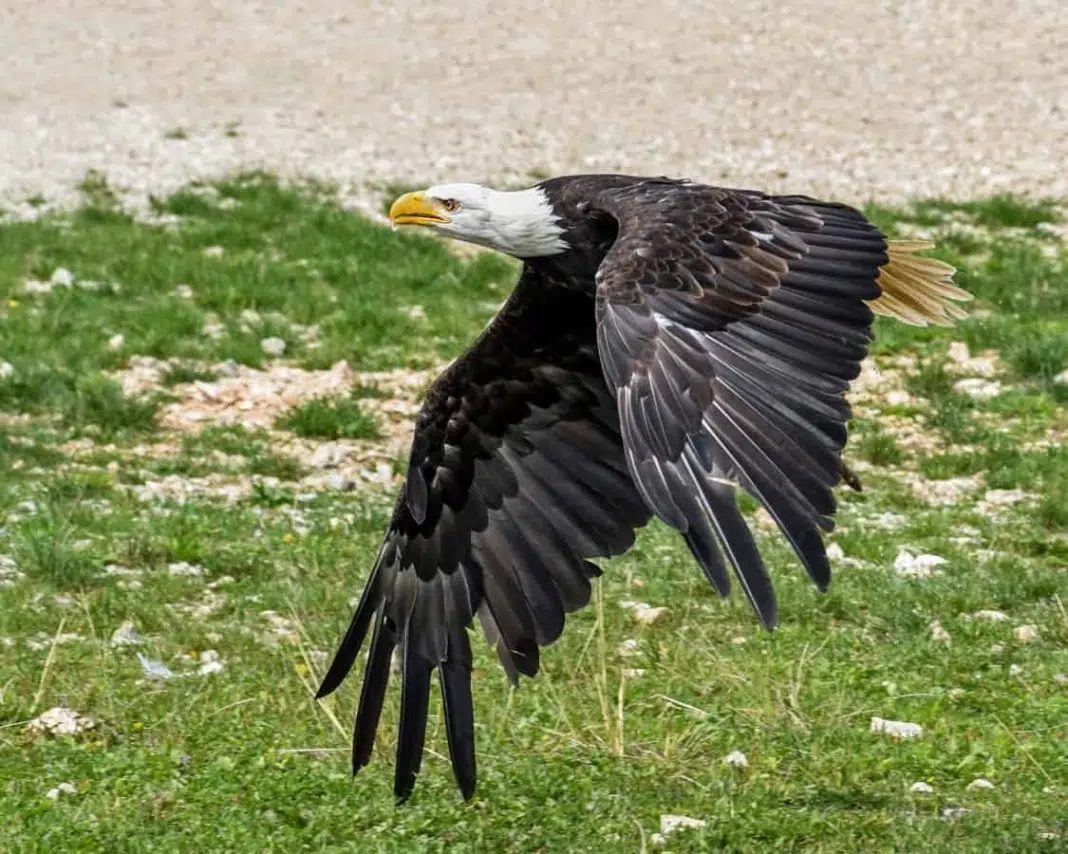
top-left (317, 175), bottom-right (969, 801)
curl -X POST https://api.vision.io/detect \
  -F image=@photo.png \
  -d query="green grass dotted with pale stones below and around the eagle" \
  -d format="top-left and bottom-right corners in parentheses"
top-left (0, 175), bottom-right (1068, 852)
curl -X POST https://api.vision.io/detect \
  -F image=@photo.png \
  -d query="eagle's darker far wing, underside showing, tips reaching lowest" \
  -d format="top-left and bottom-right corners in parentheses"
top-left (318, 268), bottom-right (650, 798)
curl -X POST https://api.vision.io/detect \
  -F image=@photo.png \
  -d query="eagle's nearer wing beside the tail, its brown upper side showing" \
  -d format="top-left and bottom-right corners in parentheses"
top-left (595, 183), bottom-right (888, 628)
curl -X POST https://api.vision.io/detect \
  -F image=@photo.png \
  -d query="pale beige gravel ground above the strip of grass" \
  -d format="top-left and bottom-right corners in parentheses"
top-left (0, 0), bottom-right (1068, 209)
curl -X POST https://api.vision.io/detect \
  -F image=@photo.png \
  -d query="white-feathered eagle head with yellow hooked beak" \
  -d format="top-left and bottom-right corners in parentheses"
top-left (390, 184), bottom-right (568, 258)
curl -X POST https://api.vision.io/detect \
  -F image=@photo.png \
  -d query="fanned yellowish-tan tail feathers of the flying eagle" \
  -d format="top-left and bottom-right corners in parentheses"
top-left (868, 240), bottom-right (972, 327)
